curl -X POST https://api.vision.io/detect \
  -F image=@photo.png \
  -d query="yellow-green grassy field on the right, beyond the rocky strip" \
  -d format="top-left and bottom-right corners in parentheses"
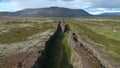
top-left (67, 17), bottom-right (120, 64)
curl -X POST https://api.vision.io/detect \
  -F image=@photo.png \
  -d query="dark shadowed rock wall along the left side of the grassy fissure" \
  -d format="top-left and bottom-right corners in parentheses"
top-left (32, 21), bottom-right (64, 68)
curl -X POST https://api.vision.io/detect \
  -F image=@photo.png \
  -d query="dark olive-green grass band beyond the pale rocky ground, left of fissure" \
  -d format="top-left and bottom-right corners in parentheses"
top-left (0, 22), bottom-right (54, 44)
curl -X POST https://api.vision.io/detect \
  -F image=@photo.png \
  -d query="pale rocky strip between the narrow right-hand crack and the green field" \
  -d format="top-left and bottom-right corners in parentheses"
top-left (78, 35), bottom-right (120, 68)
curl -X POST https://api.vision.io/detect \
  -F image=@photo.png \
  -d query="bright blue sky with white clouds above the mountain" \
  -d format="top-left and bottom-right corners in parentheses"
top-left (0, 0), bottom-right (120, 14)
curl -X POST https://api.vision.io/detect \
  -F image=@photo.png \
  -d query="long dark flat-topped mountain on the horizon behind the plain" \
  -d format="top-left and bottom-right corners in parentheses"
top-left (0, 7), bottom-right (91, 17)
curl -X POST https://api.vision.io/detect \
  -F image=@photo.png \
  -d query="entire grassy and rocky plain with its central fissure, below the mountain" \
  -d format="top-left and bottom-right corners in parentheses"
top-left (0, 17), bottom-right (120, 68)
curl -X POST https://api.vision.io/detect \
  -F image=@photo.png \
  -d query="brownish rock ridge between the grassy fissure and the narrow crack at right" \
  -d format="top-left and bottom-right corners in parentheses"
top-left (68, 33), bottom-right (101, 68)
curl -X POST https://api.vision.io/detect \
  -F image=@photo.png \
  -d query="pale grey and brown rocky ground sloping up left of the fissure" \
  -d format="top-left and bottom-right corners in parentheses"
top-left (1, 31), bottom-right (54, 68)
